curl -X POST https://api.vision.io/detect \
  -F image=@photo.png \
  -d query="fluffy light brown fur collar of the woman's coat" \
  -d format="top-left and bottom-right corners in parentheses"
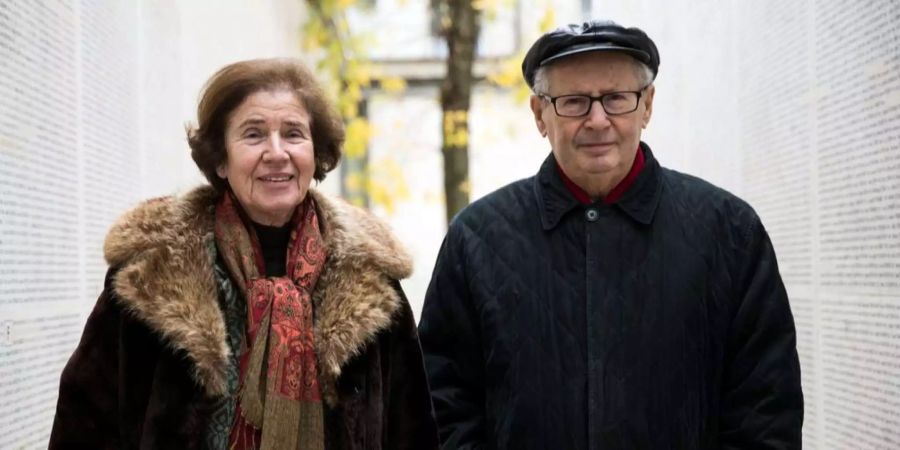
top-left (104, 186), bottom-right (412, 401)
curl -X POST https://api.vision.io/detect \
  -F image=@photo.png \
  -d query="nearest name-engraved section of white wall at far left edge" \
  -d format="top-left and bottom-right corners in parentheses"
top-left (0, 1), bottom-right (139, 449)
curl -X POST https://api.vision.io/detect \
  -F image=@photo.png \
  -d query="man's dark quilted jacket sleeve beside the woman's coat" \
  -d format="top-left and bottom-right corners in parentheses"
top-left (419, 222), bottom-right (487, 449)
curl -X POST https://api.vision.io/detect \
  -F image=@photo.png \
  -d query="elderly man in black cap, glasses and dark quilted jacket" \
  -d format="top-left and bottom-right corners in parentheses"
top-left (419, 21), bottom-right (803, 450)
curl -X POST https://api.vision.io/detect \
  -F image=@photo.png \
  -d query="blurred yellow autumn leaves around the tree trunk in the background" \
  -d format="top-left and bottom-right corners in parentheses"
top-left (300, 0), bottom-right (555, 213)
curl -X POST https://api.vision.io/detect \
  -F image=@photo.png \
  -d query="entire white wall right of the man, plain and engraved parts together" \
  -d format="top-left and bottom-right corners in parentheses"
top-left (593, 0), bottom-right (900, 449)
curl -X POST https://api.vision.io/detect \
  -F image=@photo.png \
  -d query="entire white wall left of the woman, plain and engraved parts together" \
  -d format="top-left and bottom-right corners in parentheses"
top-left (0, 0), bottom-right (302, 450)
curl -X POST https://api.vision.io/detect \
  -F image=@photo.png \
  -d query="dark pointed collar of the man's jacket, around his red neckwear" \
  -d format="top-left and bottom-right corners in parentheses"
top-left (534, 142), bottom-right (662, 230)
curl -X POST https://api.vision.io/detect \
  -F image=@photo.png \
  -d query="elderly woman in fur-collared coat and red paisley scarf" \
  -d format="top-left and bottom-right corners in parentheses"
top-left (50, 59), bottom-right (437, 450)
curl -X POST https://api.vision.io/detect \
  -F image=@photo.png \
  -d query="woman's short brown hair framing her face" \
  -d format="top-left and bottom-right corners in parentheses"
top-left (187, 58), bottom-right (344, 191)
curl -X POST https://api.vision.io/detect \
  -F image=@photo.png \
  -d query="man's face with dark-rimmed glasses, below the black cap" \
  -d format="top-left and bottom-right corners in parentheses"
top-left (531, 52), bottom-right (654, 196)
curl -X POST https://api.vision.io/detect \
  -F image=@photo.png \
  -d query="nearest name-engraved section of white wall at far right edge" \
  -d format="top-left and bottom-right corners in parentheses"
top-left (737, 0), bottom-right (900, 449)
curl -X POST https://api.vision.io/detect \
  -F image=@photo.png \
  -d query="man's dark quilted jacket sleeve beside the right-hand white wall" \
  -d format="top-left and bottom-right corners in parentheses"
top-left (720, 218), bottom-right (803, 449)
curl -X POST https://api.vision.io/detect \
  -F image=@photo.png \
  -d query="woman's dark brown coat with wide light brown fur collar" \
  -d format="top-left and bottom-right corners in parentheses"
top-left (50, 187), bottom-right (437, 450)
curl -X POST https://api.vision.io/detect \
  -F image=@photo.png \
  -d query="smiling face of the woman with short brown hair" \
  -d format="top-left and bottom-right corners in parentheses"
top-left (216, 89), bottom-right (316, 226)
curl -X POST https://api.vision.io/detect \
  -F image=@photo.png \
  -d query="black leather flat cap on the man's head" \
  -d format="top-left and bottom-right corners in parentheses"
top-left (522, 20), bottom-right (659, 88)
